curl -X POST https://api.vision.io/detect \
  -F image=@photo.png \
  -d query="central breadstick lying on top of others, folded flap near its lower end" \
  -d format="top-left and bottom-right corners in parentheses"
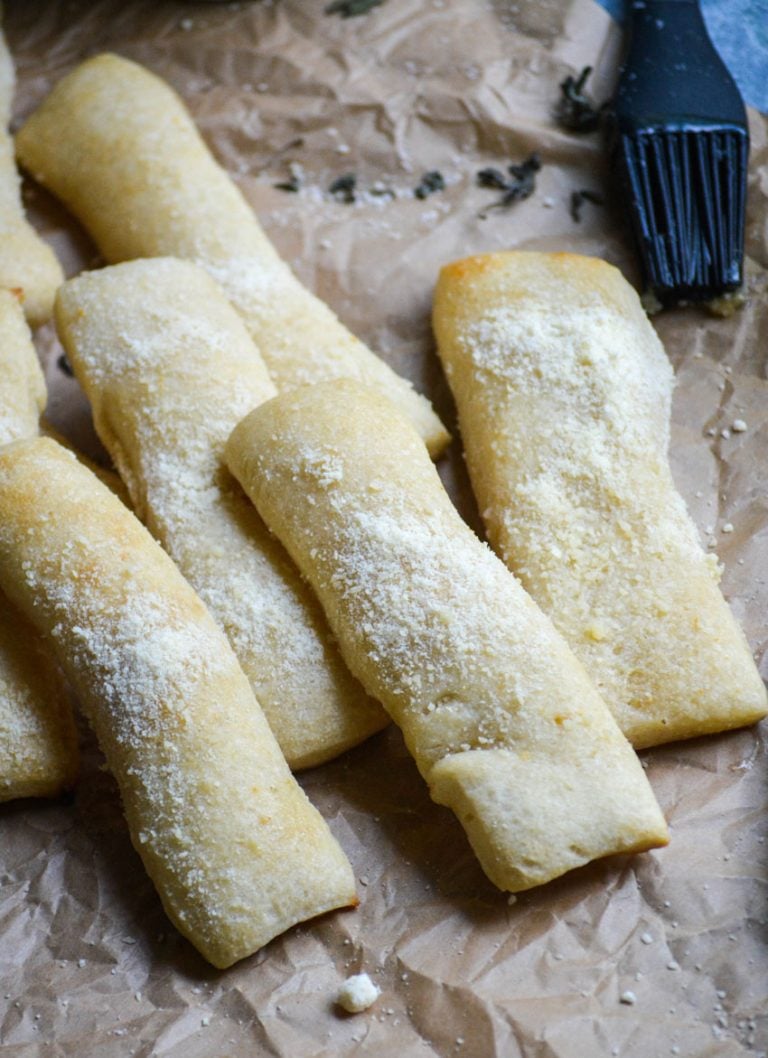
top-left (226, 380), bottom-right (666, 892)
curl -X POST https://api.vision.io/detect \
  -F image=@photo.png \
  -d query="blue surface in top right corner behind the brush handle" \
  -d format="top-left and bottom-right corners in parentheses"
top-left (598, 0), bottom-right (768, 113)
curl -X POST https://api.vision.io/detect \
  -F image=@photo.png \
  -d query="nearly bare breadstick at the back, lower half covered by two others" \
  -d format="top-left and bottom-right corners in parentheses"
top-left (17, 55), bottom-right (449, 456)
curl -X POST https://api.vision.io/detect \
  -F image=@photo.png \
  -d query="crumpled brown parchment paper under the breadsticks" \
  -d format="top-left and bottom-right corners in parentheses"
top-left (0, 0), bottom-right (768, 1058)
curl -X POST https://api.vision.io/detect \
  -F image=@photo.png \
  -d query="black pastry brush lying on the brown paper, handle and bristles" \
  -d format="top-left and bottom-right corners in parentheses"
top-left (614, 0), bottom-right (749, 305)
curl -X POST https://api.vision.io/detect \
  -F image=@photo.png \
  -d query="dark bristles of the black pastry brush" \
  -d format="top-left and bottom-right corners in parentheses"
top-left (619, 127), bottom-right (749, 303)
